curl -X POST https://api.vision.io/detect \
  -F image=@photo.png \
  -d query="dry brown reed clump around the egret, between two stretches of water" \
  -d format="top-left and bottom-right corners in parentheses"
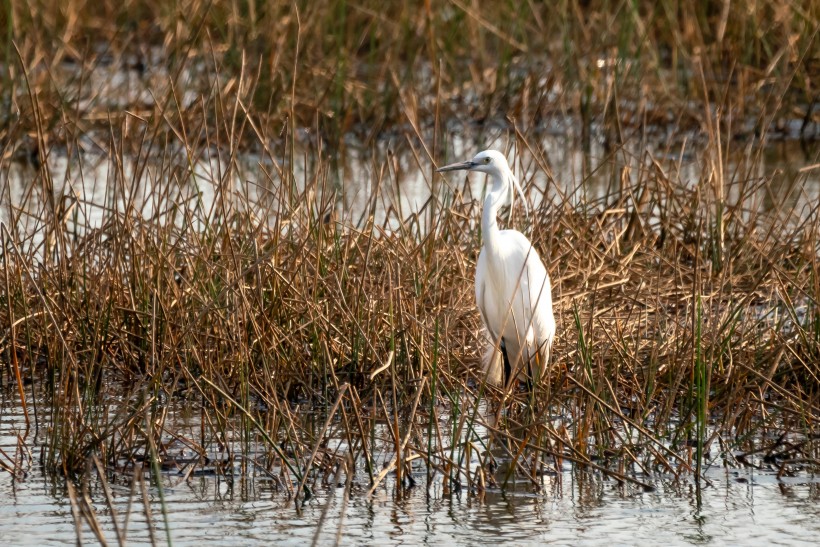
top-left (0, 111), bottom-right (820, 492)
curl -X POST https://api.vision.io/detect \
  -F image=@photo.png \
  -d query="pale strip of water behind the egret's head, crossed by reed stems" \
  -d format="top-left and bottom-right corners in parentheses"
top-left (0, 126), bottom-right (820, 258)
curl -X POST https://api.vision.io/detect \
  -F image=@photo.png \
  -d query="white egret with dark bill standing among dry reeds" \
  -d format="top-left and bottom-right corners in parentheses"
top-left (438, 150), bottom-right (555, 385)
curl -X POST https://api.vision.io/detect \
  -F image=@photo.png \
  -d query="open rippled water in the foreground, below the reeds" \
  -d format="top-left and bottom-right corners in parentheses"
top-left (0, 399), bottom-right (820, 545)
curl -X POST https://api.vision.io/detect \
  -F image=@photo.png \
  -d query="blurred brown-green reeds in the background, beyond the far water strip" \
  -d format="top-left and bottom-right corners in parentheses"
top-left (0, 0), bottom-right (820, 143)
